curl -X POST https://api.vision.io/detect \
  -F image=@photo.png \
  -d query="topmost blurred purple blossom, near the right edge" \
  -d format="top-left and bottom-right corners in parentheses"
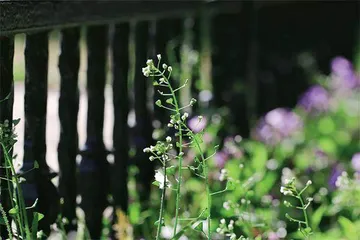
top-left (331, 56), bottom-right (360, 89)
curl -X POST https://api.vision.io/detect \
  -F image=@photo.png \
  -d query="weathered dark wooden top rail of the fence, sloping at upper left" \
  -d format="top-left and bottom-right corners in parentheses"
top-left (0, 0), bottom-right (241, 35)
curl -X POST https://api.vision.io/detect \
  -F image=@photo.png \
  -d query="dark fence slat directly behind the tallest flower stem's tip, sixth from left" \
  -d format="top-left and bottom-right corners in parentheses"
top-left (134, 21), bottom-right (154, 206)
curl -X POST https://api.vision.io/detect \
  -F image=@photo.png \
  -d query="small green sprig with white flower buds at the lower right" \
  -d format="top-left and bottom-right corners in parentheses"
top-left (280, 177), bottom-right (313, 237)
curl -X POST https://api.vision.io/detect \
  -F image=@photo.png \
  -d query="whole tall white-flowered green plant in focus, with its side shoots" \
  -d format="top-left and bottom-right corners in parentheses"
top-left (142, 55), bottom-right (229, 239)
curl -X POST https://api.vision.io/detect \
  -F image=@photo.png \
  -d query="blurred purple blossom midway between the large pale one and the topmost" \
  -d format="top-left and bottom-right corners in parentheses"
top-left (298, 85), bottom-right (329, 113)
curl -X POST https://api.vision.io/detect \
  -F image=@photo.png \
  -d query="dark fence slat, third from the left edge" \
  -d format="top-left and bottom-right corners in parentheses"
top-left (58, 28), bottom-right (80, 231)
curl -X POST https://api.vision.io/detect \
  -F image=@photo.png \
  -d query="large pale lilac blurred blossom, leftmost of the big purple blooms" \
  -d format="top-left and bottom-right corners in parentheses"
top-left (255, 108), bottom-right (303, 145)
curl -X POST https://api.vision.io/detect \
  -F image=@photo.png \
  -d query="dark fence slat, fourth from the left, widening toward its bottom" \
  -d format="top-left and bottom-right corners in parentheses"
top-left (79, 26), bottom-right (110, 239)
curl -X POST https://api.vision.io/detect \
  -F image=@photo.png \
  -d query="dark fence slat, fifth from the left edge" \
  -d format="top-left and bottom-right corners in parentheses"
top-left (112, 22), bottom-right (130, 214)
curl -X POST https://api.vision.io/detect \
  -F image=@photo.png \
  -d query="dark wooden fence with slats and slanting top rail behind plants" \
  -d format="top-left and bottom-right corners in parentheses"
top-left (0, 0), bottom-right (359, 239)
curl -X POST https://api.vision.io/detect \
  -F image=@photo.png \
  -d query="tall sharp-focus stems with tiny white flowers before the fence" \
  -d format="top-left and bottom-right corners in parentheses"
top-left (142, 55), bottom-right (212, 239)
